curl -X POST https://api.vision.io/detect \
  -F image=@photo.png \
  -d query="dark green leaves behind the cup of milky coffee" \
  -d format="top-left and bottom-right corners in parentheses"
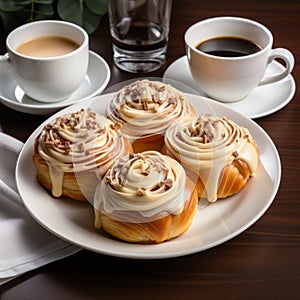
top-left (0, 0), bottom-right (109, 34)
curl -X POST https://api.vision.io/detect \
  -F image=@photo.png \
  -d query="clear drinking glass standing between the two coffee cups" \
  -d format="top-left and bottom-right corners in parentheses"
top-left (108, 0), bottom-right (172, 73)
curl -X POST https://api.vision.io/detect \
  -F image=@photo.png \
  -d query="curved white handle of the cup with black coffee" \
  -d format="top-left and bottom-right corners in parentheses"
top-left (259, 48), bottom-right (295, 86)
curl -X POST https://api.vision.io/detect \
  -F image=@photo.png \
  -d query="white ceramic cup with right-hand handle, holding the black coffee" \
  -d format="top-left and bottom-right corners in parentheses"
top-left (184, 17), bottom-right (294, 102)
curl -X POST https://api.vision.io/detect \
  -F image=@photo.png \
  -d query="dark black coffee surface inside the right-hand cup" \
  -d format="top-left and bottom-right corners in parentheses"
top-left (196, 37), bottom-right (261, 57)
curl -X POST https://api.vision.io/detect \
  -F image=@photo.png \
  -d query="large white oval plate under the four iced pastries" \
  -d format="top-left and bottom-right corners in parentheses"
top-left (16, 94), bottom-right (281, 259)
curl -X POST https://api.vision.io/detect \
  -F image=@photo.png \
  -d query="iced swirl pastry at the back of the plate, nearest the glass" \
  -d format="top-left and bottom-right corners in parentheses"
top-left (106, 80), bottom-right (194, 152)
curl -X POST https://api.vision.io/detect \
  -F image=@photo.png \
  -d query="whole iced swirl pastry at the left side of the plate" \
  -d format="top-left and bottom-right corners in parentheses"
top-left (33, 109), bottom-right (132, 200)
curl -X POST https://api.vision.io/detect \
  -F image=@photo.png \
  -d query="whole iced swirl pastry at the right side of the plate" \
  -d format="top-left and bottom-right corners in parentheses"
top-left (162, 115), bottom-right (259, 202)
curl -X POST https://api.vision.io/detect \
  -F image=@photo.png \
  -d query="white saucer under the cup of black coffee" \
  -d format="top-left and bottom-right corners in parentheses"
top-left (163, 56), bottom-right (296, 119)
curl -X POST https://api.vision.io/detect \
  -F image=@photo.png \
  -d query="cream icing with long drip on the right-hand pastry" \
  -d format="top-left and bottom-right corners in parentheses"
top-left (165, 115), bottom-right (259, 202)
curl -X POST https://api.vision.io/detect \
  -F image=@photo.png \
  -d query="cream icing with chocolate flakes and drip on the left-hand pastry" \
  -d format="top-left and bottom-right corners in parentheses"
top-left (38, 109), bottom-right (125, 197)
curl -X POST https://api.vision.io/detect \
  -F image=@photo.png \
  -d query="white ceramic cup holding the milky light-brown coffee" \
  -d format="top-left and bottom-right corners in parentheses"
top-left (0, 20), bottom-right (89, 103)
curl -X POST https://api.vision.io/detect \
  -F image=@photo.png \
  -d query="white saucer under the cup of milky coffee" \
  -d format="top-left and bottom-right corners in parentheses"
top-left (0, 51), bottom-right (111, 115)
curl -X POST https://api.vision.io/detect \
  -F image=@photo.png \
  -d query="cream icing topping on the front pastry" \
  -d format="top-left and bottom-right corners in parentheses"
top-left (94, 151), bottom-right (187, 224)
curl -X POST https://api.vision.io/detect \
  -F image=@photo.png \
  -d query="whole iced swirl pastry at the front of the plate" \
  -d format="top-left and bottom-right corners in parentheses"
top-left (94, 151), bottom-right (198, 243)
